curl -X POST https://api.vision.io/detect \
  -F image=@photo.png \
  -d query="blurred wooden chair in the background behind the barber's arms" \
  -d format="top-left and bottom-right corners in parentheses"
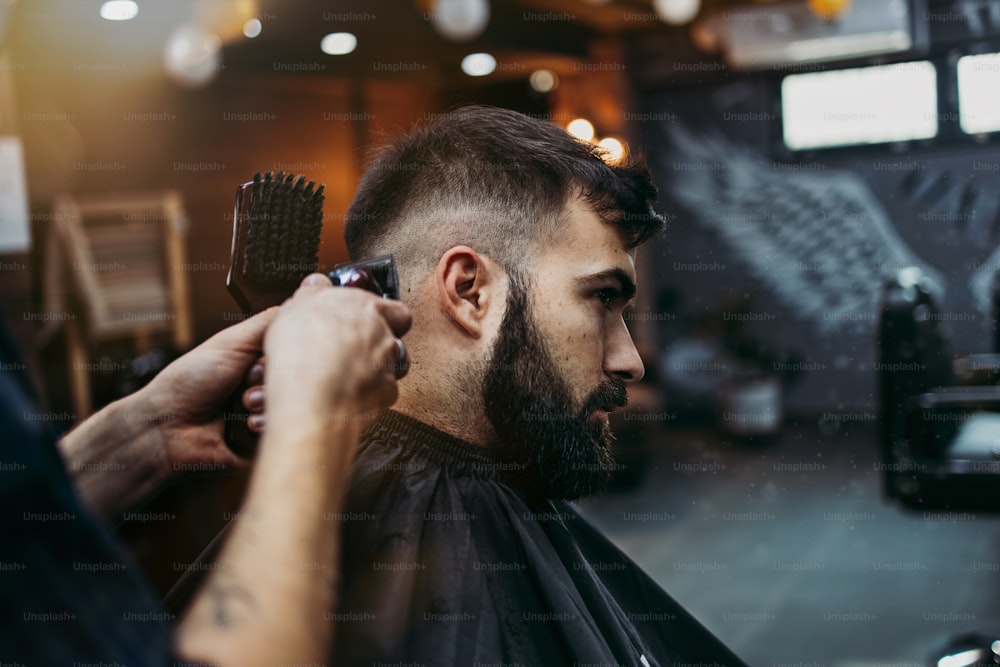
top-left (39, 190), bottom-right (192, 420)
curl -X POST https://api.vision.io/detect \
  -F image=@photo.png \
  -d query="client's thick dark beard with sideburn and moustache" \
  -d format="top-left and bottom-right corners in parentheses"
top-left (482, 273), bottom-right (628, 500)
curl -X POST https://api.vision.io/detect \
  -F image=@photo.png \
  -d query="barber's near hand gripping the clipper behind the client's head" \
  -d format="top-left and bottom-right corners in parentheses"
top-left (260, 274), bottom-right (411, 434)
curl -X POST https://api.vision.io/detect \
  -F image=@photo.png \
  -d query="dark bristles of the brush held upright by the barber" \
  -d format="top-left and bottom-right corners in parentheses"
top-left (244, 171), bottom-right (323, 285)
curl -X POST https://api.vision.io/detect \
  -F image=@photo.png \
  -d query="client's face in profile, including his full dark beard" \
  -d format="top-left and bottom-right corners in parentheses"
top-left (483, 201), bottom-right (643, 499)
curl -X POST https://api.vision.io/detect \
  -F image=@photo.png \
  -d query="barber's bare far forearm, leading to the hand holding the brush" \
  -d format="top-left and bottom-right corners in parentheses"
top-left (59, 394), bottom-right (168, 520)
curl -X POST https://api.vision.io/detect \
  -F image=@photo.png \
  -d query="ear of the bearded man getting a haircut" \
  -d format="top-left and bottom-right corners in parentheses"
top-left (435, 246), bottom-right (499, 338)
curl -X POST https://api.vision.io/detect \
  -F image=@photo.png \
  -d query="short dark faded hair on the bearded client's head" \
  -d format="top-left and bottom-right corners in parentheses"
top-left (344, 106), bottom-right (663, 270)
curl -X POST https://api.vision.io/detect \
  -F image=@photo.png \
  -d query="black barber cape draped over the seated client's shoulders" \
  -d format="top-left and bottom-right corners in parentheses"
top-left (332, 410), bottom-right (744, 667)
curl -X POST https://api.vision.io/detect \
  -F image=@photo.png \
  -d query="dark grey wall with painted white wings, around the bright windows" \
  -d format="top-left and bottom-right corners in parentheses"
top-left (630, 5), bottom-right (1000, 419)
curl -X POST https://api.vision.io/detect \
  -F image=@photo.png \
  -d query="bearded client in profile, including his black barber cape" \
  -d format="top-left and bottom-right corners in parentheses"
top-left (332, 107), bottom-right (743, 667)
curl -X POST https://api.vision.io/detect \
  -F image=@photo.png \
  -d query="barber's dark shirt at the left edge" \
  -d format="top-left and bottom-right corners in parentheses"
top-left (0, 318), bottom-right (178, 667)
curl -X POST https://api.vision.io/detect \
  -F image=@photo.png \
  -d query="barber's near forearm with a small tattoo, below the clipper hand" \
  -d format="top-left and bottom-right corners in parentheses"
top-left (178, 413), bottom-right (361, 665)
